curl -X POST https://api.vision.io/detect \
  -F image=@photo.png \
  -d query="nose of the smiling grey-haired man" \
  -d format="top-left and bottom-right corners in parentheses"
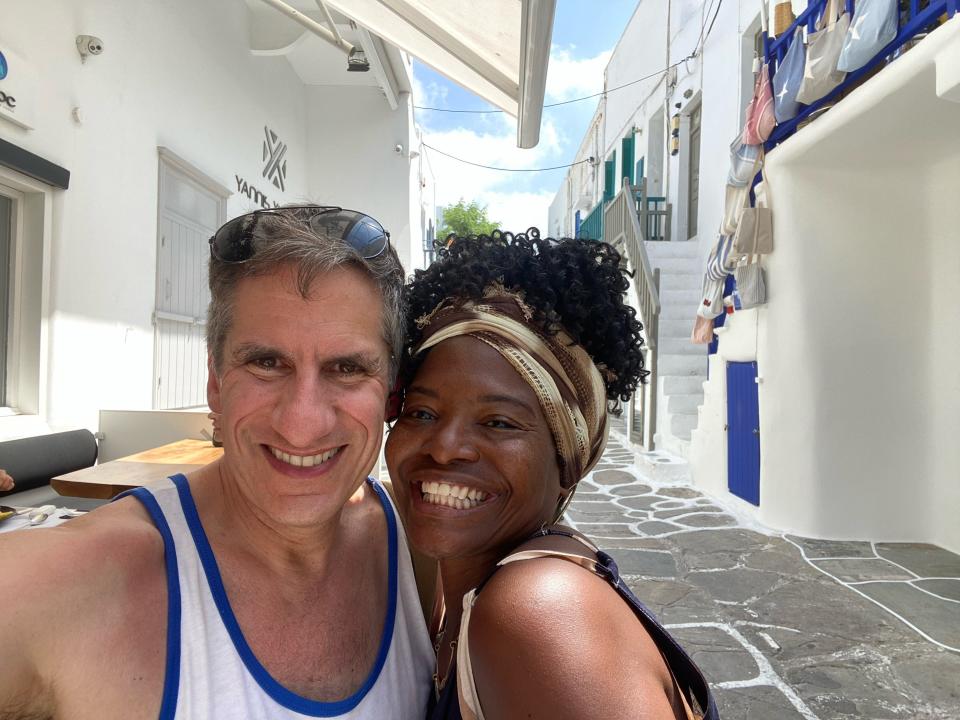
top-left (274, 374), bottom-right (338, 449)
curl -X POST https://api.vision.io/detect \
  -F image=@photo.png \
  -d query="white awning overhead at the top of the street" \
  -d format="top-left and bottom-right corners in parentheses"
top-left (324, 0), bottom-right (556, 148)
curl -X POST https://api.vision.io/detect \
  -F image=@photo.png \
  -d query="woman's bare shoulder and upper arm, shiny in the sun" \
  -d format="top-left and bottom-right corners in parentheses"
top-left (469, 541), bottom-right (675, 720)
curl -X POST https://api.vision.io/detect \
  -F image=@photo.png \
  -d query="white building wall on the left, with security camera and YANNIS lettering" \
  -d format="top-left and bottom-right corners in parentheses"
top-left (0, 0), bottom-right (420, 434)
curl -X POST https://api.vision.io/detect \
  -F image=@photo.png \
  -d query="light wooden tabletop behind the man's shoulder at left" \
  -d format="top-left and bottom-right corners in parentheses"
top-left (50, 440), bottom-right (223, 500)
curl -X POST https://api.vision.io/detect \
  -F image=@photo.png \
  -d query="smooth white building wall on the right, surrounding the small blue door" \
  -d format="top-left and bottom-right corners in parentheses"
top-left (691, 18), bottom-right (960, 550)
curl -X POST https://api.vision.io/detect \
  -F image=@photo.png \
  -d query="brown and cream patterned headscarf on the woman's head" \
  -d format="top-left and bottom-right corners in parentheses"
top-left (413, 285), bottom-right (607, 489)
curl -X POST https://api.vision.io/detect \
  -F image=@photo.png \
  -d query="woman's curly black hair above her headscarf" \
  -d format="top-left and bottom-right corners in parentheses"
top-left (401, 228), bottom-right (649, 412)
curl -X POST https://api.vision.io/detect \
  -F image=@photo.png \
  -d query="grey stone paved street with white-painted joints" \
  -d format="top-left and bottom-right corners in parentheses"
top-left (568, 432), bottom-right (960, 720)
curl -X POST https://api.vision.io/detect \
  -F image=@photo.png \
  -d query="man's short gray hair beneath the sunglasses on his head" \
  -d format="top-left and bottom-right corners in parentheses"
top-left (207, 208), bottom-right (406, 384)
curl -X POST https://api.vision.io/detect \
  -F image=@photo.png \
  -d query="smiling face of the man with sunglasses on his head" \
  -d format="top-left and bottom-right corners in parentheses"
top-left (207, 268), bottom-right (389, 527)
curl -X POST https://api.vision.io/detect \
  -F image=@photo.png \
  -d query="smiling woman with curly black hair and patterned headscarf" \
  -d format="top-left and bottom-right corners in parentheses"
top-left (386, 229), bottom-right (716, 720)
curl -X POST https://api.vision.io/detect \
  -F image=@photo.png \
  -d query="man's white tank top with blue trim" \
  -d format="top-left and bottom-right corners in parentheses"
top-left (129, 475), bottom-right (435, 720)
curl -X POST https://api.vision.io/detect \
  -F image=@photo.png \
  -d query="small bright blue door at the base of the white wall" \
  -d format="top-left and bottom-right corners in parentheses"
top-left (727, 362), bottom-right (760, 505)
